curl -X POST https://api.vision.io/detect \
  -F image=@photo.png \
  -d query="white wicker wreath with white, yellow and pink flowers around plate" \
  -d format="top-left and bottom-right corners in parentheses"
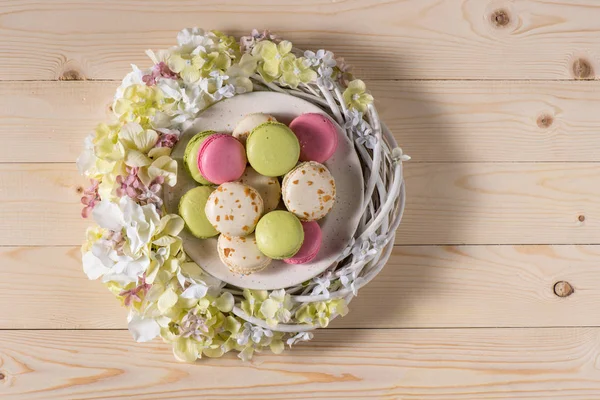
top-left (77, 28), bottom-right (409, 362)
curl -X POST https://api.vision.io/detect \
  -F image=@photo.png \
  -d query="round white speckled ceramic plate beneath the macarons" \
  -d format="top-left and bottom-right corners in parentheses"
top-left (165, 92), bottom-right (364, 289)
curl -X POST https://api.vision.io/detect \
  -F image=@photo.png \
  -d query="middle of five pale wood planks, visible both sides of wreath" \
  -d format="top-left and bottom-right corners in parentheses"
top-left (0, 163), bottom-right (600, 246)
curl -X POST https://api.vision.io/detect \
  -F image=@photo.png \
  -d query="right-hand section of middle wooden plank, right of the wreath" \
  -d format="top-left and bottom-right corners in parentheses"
top-left (396, 163), bottom-right (600, 244)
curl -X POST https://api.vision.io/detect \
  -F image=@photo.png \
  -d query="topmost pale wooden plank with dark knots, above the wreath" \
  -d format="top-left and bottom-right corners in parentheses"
top-left (0, 0), bottom-right (600, 80)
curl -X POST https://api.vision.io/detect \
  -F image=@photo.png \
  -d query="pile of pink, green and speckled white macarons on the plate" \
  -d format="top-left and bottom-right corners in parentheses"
top-left (179, 113), bottom-right (338, 275)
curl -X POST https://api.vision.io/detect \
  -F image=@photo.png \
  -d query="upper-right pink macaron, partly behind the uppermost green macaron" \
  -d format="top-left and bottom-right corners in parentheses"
top-left (290, 113), bottom-right (338, 163)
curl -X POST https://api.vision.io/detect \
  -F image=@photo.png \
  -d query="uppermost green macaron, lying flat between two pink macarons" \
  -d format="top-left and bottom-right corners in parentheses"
top-left (246, 122), bottom-right (300, 176)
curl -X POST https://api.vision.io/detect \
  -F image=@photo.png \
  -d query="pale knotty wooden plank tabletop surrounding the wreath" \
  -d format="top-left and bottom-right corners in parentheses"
top-left (0, 0), bottom-right (600, 400)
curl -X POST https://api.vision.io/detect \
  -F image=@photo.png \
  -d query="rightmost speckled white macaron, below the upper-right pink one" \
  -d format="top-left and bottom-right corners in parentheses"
top-left (282, 161), bottom-right (335, 221)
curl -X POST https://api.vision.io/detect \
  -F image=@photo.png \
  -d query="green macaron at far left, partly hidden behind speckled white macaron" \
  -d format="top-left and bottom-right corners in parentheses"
top-left (179, 186), bottom-right (219, 239)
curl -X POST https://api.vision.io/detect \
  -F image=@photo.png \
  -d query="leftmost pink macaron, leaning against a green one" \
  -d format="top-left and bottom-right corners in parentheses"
top-left (198, 133), bottom-right (247, 185)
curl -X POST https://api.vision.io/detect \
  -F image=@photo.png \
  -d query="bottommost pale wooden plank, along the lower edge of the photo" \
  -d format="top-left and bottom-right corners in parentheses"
top-left (0, 328), bottom-right (600, 400)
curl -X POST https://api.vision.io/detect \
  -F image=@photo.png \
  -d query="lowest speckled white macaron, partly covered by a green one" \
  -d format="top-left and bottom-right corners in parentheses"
top-left (217, 234), bottom-right (271, 275)
